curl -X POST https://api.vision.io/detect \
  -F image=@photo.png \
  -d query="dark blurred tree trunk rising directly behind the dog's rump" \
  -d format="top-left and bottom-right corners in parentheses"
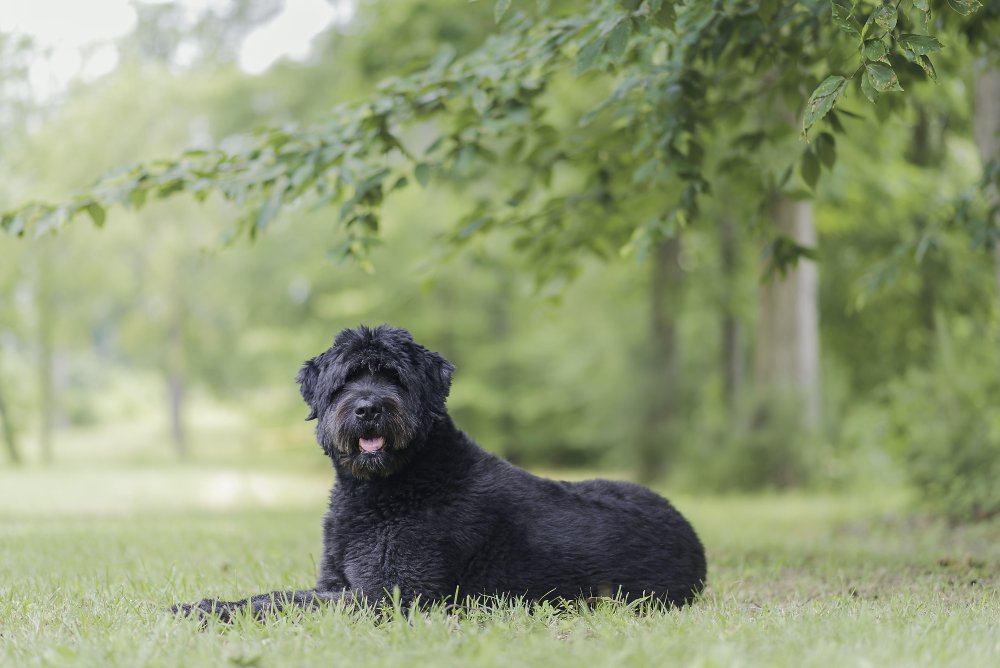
top-left (636, 238), bottom-right (682, 482)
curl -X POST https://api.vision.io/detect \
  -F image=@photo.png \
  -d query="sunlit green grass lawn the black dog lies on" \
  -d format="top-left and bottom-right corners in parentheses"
top-left (0, 467), bottom-right (1000, 667)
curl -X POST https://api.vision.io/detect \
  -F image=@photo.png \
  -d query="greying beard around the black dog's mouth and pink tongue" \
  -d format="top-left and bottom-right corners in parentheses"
top-left (329, 400), bottom-right (417, 480)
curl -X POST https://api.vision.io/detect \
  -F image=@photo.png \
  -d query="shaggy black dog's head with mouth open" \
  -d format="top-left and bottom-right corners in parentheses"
top-left (298, 325), bottom-right (455, 480)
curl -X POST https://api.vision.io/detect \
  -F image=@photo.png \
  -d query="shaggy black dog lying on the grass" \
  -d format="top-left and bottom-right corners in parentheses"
top-left (175, 325), bottom-right (705, 620)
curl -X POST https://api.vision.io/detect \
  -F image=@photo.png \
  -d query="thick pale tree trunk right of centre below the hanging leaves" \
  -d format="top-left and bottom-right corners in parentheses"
top-left (755, 195), bottom-right (821, 427)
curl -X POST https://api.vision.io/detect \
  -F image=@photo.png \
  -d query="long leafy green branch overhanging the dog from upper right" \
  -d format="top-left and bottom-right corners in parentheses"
top-left (2, 0), bottom-right (996, 278)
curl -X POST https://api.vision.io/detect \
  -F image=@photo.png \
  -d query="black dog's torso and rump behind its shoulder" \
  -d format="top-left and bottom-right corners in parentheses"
top-left (450, 438), bottom-right (706, 604)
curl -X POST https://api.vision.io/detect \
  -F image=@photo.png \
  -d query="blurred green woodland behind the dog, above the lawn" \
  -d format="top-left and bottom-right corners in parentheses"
top-left (0, 0), bottom-right (1000, 517)
